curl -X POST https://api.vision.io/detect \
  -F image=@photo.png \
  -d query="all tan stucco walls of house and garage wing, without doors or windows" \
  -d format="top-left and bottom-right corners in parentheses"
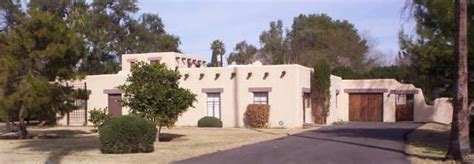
top-left (59, 52), bottom-right (452, 128)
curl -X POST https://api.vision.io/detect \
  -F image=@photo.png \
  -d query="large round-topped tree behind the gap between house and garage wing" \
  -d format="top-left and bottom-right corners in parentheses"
top-left (287, 14), bottom-right (368, 69)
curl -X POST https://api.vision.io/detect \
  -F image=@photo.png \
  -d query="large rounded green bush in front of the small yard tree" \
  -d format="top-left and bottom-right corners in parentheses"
top-left (99, 116), bottom-right (157, 154)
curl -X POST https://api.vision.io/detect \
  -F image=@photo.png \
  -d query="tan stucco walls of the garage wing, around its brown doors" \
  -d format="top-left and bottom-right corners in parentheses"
top-left (327, 76), bottom-right (453, 124)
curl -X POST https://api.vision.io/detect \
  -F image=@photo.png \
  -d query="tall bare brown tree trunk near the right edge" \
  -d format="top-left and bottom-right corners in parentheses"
top-left (447, 0), bottom-right (471, 161)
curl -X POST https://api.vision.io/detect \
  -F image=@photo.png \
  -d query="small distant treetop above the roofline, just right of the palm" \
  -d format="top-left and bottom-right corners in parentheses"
top-left (227, 41), bottom-right (258, 64)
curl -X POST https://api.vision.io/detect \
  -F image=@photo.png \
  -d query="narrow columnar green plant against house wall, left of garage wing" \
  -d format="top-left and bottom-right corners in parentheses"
top-left (311, 58), bottom-right (331, 123)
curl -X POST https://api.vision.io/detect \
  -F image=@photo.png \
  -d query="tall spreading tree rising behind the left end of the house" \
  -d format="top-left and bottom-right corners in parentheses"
top-left (27, 0), bottom-right (180, 74)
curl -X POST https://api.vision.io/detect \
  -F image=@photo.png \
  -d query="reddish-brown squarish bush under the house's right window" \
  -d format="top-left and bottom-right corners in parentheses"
top-left (244, 104), bottom-right (270, 128)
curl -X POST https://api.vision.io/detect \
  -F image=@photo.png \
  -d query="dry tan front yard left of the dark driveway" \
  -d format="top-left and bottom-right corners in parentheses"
top-left (0, 127), bottom-right (314, 163)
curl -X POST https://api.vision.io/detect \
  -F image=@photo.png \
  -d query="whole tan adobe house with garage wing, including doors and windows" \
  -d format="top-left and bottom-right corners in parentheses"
top-left (58, 52), bottom-right (452, 128)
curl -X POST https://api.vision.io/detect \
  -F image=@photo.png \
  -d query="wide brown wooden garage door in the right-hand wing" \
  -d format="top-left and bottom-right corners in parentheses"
top-left (349, 93), bottom-right (383, 121)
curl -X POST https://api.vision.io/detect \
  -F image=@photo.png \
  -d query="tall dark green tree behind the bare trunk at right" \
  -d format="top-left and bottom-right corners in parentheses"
top-left (400, 0), bottom-right (474, 101)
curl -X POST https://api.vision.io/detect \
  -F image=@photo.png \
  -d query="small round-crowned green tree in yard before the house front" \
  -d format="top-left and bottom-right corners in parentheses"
top-left (120, 62), bottom-right (196, 137)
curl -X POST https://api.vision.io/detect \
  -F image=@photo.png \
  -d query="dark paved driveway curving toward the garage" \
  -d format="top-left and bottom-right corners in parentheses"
top-left (177, 122), bottom-right (421, 164)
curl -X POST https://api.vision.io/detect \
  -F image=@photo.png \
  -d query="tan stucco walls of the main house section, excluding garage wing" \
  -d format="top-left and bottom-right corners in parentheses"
top-left (60, 52), bottom-right (311, 127)
